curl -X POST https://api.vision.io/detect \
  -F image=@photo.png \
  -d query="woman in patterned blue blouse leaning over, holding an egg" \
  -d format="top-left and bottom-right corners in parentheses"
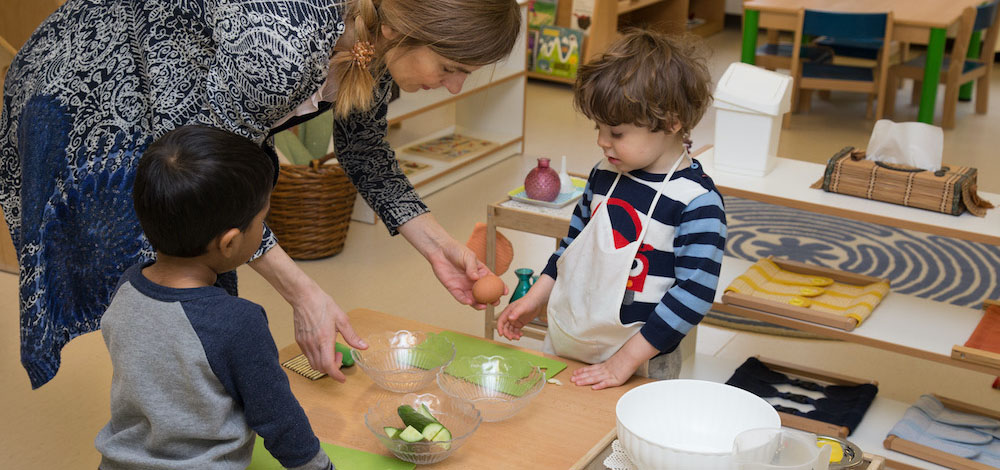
top-left (0, 0), bottom-right (521, 388)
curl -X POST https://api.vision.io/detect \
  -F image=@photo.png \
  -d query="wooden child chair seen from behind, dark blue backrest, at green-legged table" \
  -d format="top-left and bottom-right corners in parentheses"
top-left (785, 10), bottom-right (892, 128)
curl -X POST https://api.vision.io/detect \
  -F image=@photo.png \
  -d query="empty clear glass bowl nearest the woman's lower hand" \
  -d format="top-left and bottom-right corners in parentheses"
top-left (351, 330), bottom-right (455, 393)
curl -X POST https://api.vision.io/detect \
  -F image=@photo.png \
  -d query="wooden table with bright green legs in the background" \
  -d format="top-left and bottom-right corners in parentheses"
top-left (741, 0), bottom-right (983, 124)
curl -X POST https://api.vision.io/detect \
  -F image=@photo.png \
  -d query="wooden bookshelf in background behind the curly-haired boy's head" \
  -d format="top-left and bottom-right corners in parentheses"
top-left (528, 0), bottom-right (726, 83)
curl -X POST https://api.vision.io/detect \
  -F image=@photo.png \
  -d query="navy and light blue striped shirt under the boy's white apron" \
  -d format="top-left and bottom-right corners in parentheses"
top-left (542, 160), bottom-right (726, 352)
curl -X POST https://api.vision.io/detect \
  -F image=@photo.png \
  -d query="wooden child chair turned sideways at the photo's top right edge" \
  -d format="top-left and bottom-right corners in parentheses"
top-left (886, 0), bottom-right (1000, 129)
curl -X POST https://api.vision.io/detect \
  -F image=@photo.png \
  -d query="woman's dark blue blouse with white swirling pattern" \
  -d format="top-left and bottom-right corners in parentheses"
top-left (0, 0), bottom-right (427, 388)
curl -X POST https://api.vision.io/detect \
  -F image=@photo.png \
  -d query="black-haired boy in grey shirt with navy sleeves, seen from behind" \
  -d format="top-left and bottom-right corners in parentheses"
top-left (95, 126), bottom-right (333, 470)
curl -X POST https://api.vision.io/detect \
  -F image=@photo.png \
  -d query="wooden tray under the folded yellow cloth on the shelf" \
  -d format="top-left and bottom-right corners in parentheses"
top-left (722, 257), bottom-right (889, 331)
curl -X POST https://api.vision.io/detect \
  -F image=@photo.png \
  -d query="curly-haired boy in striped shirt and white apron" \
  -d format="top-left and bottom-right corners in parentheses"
top-left (497, 30), bottom-right (726, 389)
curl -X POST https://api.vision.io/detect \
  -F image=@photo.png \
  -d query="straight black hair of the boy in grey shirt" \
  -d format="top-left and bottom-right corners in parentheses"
top-left (132, 126), bottom-right (274, 257)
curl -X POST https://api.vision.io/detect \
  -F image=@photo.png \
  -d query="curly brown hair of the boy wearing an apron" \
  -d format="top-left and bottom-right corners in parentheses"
top-left (573, 29), bottom-right (712, 140)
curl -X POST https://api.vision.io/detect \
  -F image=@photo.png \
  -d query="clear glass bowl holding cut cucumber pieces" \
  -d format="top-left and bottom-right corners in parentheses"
top-left (365, 393), bottom-right (483, 465)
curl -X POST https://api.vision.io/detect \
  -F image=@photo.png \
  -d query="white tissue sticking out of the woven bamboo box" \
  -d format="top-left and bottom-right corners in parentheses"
top-left (865, 119), bottom-right (944, 171)
